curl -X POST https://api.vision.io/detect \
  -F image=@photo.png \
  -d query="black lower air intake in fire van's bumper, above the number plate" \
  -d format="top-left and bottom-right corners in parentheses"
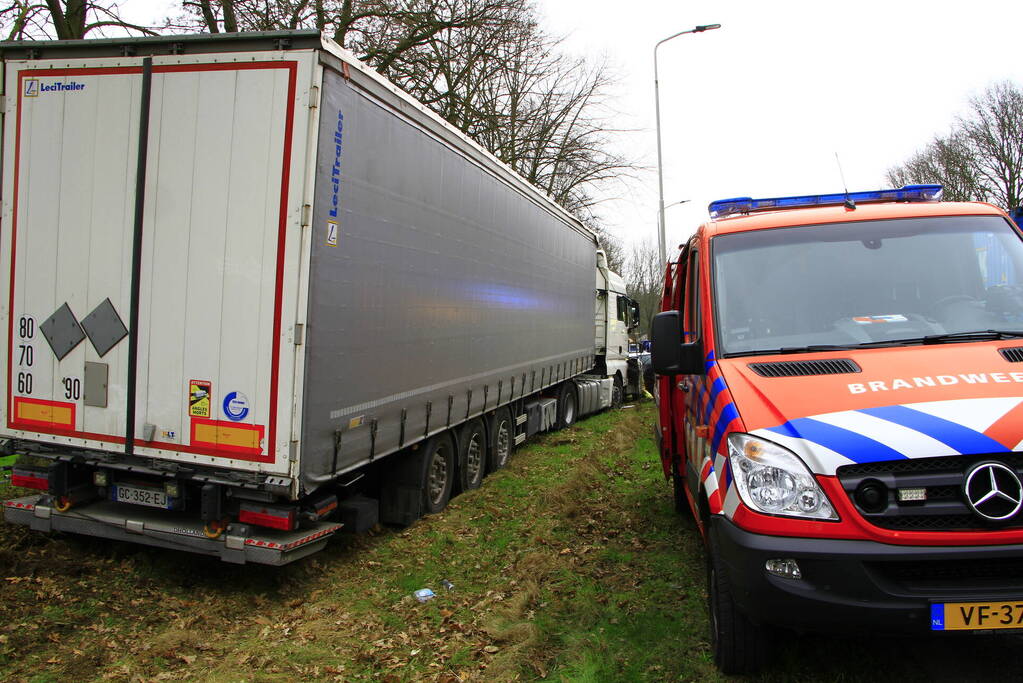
top-left (866, 557), bottom-right (1023, 592)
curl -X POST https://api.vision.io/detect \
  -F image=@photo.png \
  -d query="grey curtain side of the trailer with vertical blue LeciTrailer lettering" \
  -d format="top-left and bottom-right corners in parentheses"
top-left (301, 69), bottom-right (594, 490)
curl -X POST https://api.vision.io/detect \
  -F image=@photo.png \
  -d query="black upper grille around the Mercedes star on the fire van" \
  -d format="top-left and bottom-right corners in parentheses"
top-left (837, 453), bottom-right (1023, 532)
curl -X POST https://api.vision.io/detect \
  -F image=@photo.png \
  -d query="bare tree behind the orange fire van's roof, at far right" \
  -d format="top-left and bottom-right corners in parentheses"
top-left (887, 82), bottom-right (1023, 209)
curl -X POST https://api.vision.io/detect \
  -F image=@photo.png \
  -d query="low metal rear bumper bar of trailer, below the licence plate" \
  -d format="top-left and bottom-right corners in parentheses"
top-left (4, 496), bottom-right (342, 565)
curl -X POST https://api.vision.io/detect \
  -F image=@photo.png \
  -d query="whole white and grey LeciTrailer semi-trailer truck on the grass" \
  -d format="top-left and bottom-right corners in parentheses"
top-left (0, 32), bottom-right (637, 564)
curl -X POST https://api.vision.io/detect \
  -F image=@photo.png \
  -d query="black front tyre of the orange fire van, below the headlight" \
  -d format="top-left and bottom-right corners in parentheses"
top-left (707, 534), bottom-right (767, 675)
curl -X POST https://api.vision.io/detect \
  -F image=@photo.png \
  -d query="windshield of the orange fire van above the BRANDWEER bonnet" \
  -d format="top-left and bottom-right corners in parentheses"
top-left (712, 216), bottom-right (1023, 355)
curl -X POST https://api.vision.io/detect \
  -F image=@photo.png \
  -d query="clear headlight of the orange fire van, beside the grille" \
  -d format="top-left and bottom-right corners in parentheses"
top-left (728, 434), bottom-right (838, 519)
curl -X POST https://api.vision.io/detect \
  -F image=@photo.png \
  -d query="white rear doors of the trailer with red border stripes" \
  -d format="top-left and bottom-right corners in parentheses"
top-left (0, 51), bottom-right (314, 472)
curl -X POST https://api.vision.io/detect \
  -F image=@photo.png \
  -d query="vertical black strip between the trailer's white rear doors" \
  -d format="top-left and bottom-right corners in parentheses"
top-left (125, 57), bottom-right (152, 455)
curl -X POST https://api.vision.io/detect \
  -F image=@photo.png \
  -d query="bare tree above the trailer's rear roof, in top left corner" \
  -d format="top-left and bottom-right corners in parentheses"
top-left (0, 0), bottom-right (157, 40)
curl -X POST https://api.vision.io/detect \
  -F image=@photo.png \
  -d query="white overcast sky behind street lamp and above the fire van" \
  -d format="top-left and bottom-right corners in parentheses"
top-left (129, 0), bottom-right (1023, 253)
